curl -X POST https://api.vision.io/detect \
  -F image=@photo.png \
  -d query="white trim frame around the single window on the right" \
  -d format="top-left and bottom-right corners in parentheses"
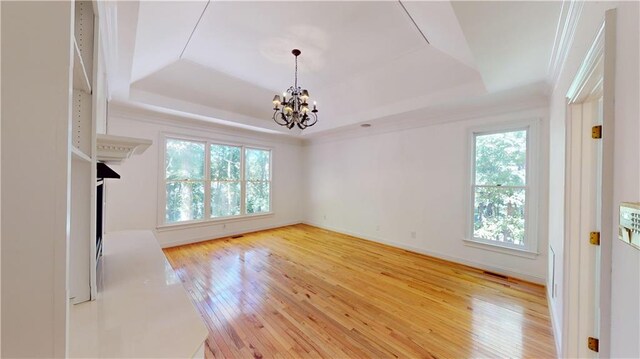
top-left (463, 118), bottom-right (540, 259)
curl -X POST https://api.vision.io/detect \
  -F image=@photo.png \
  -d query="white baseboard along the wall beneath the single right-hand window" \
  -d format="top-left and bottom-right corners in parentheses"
top-left (302, 221), bottom-right (546, 285)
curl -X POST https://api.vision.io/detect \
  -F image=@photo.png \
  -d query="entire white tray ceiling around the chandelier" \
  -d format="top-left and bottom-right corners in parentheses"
top-left (113, 1), bottom-right (561, 136)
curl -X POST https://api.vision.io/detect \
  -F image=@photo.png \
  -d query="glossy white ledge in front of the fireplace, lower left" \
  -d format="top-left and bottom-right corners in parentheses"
top-left (69, 231), bottom-right (208, 358)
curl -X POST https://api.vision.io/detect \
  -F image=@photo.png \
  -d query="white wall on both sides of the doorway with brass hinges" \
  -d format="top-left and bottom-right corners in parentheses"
top-left (549, 2), bottom-right (640, 358)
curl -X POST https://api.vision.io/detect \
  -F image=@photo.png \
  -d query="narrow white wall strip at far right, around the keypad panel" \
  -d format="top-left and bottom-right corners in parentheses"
top-left (611, 2), bottom-right (640, 358)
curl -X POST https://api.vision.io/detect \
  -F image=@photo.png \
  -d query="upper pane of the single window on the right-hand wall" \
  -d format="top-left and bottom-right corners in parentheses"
top-left (475, 130), bottom-right (527, 186)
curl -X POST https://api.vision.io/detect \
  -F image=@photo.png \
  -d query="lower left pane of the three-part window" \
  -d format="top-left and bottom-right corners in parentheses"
top-left (165, 181), bottom-right (204, 223)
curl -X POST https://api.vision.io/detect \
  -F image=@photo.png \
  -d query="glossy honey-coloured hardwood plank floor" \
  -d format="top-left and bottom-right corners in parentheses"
top-left (165, 225), bottom-right (555, 358)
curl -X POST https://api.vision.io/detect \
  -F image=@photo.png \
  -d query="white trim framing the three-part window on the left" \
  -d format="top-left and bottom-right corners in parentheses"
top-left (156, 133), bottom-right (275, 230)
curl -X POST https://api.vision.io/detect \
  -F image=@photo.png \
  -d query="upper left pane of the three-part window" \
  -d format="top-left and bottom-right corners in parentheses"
top-left (165, 139), bottom-right (204, 181)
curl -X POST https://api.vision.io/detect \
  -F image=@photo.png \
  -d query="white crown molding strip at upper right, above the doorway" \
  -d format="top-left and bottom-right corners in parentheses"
top-left (547, 0), bottom-right (584, 88)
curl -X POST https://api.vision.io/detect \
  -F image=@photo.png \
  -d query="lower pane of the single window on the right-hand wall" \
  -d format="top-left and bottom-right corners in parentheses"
top-left (473, 187), bottom-right (525, 246)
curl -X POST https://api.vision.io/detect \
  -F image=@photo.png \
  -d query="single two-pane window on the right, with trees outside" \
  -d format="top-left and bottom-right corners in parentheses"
top-left (470, 125), bottom-right (536, 252)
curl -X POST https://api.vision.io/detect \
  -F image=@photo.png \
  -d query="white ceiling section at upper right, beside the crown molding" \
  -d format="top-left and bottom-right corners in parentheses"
top-left (452, 1), bottom-right (562, 92)
